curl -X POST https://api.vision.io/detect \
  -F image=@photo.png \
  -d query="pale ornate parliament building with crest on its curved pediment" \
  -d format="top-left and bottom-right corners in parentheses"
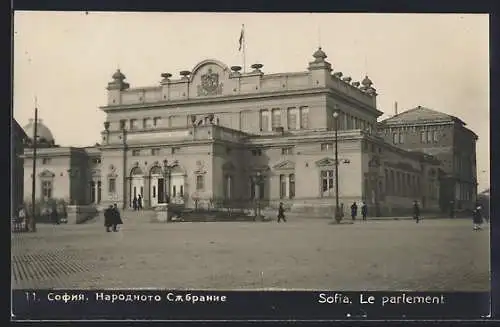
top-left (24, 48), bottom-right (452, 215)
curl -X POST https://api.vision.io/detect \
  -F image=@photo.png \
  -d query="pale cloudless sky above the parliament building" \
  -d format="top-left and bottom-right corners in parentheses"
top-left (13, 11), bottom-right (490, 191)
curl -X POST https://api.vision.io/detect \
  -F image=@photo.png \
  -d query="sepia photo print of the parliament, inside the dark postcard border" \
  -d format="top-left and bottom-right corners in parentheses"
top-left (11, 11), bottom-right (490, 292)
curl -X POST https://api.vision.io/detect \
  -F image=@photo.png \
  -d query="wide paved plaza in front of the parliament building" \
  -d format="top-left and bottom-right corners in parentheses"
top-left (12, 213), bottom-right (490, 291)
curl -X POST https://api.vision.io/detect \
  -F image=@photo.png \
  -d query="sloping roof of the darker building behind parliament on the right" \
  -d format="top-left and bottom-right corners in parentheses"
top-left (381, 106), bottom-right (465, 126)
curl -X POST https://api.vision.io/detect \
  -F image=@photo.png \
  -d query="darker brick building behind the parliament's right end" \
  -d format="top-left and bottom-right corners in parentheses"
top-left (379, 106), bottom-right (478, 212)
